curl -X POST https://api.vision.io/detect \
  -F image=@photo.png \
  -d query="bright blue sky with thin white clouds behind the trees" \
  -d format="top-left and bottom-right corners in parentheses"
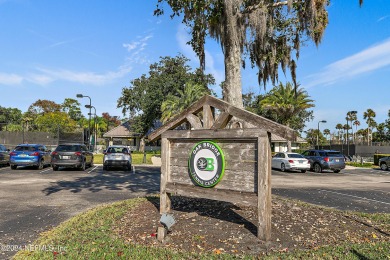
top-left (0, 0), bottom-right (390, 132)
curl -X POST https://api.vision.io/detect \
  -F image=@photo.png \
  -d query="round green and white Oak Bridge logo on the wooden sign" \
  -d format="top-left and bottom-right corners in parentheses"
top-left (188, 141), bottom-right (225, 188)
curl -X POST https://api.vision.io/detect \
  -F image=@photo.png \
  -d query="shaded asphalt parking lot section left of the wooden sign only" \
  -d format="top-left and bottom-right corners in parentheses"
top-left (0, 166), bottom-right (160, 259)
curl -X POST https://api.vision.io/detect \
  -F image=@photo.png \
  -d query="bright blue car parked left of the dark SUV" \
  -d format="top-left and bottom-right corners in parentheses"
top-left (9, 144), bottom-right (51, 170)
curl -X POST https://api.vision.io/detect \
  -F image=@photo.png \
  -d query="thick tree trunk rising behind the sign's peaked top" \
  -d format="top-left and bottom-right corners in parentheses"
top-left (222, 0), bottom-right (244, 108)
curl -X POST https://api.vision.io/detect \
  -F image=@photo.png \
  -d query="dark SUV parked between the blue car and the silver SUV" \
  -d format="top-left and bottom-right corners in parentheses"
top-left (51, 144), bottom-right (93, 171)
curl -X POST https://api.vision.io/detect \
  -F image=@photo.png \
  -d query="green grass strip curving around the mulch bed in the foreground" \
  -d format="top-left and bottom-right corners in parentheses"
top-left (14, 198), bottom-right (390, 259)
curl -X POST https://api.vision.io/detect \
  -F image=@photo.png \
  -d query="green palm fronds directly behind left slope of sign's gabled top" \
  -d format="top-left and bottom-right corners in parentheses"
top-left (161, 82), bottom-right (210, 123)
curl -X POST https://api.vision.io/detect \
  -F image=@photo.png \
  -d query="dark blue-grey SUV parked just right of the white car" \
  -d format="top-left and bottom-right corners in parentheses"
top-left (302, 150), bottom-right (345, 173)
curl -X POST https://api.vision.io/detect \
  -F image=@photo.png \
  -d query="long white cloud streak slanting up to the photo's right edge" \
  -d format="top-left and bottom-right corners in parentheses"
top-left (304, 39), bottom-right (390, 88)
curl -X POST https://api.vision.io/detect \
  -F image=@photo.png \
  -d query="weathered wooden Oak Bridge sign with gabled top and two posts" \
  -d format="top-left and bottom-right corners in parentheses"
top-left (148, 96), bottom-right (295, 241)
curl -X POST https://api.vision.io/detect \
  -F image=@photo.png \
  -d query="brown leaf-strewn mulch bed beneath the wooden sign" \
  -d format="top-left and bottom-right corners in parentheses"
top-left (117, 196), bottom-right (390, 255)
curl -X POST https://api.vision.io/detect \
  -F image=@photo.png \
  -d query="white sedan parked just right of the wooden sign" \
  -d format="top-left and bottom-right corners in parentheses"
top-left (272, 152), bottom-right (310, 172)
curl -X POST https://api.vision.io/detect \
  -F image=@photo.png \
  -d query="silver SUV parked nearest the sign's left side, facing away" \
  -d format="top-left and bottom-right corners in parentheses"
top-left (103, 145), bottom-right (132, 171)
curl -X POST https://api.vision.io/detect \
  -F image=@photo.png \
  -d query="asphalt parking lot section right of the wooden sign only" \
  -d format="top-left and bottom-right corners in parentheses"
top-left (272, 168), bottom-right (390, 213)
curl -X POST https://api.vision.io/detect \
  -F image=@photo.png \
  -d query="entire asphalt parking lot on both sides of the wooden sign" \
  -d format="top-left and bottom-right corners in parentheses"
top-left (0, 165), bottom-right (390, 259)
